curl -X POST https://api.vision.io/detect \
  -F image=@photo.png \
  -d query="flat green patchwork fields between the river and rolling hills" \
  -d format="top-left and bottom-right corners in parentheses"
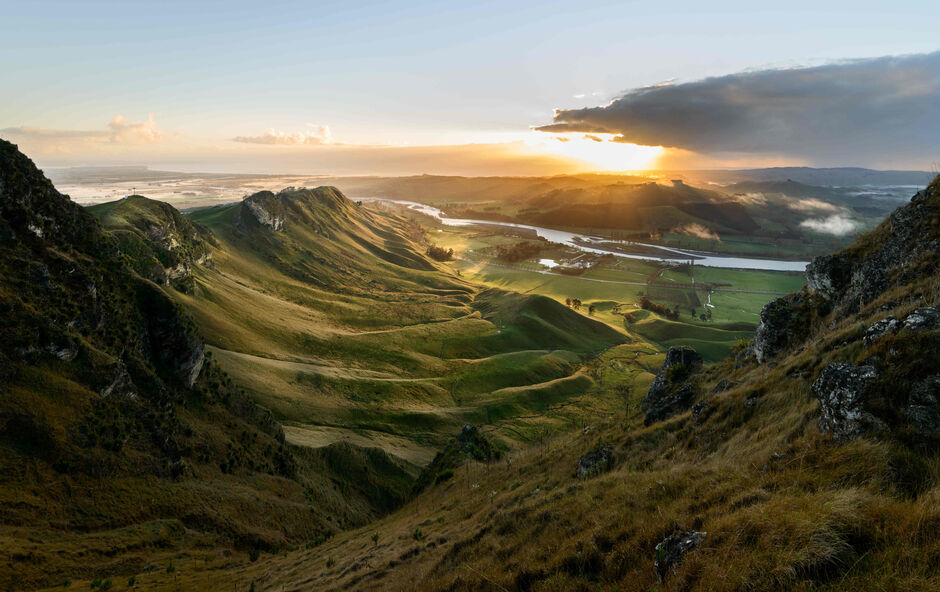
top-left (422, 219), bottom-right (804, 361)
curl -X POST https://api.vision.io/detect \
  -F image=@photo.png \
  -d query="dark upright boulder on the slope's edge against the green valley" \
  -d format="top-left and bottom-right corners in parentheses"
top-left (641, 347), bottom-right (702, 425)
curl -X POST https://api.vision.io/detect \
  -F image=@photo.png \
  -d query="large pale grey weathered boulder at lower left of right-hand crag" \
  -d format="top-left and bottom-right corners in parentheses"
top-left (813, 362), bottom-right (887, 442)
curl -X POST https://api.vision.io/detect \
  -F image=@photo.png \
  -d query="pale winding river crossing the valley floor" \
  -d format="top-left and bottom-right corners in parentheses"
top-left (357, 197), bottom-right (808, 271)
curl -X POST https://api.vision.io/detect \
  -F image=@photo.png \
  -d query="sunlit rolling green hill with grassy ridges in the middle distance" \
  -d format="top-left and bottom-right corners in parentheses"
top-left (94, 187), bottom-right (626, 464)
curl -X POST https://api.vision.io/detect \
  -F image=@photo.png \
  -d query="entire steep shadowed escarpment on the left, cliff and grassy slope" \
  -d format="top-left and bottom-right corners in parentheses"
top-left (0, 141), bottom-right (411, 590)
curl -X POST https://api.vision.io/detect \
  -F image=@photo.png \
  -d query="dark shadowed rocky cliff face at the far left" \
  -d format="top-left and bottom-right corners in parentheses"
top-left (0, 142), bottom-right (213, 448)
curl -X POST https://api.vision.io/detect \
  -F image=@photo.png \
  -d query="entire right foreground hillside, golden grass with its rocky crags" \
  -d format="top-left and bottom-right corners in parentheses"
top-left (119, 179), bottom-right (940, 592)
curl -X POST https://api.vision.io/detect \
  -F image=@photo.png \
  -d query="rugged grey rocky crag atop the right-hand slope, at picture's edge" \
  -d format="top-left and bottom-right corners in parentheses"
top-left (749, 179), bottom-right (940, 441)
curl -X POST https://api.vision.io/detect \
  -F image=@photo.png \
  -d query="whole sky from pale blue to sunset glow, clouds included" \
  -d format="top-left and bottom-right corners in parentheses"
top-left (0, 0), bottom-right (940, 175)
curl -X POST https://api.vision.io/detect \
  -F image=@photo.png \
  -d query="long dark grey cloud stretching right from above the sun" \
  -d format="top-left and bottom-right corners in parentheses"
top-left (536, 52), bottom-right (940, 160)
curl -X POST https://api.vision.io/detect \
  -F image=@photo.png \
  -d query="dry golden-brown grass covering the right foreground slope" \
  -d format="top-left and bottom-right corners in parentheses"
top-left (62, 306), bottom-right (940, 592)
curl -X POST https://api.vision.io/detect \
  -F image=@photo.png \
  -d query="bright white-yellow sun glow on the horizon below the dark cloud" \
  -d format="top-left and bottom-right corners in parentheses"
top-left (533, 132), bottom-right (665, 171)
